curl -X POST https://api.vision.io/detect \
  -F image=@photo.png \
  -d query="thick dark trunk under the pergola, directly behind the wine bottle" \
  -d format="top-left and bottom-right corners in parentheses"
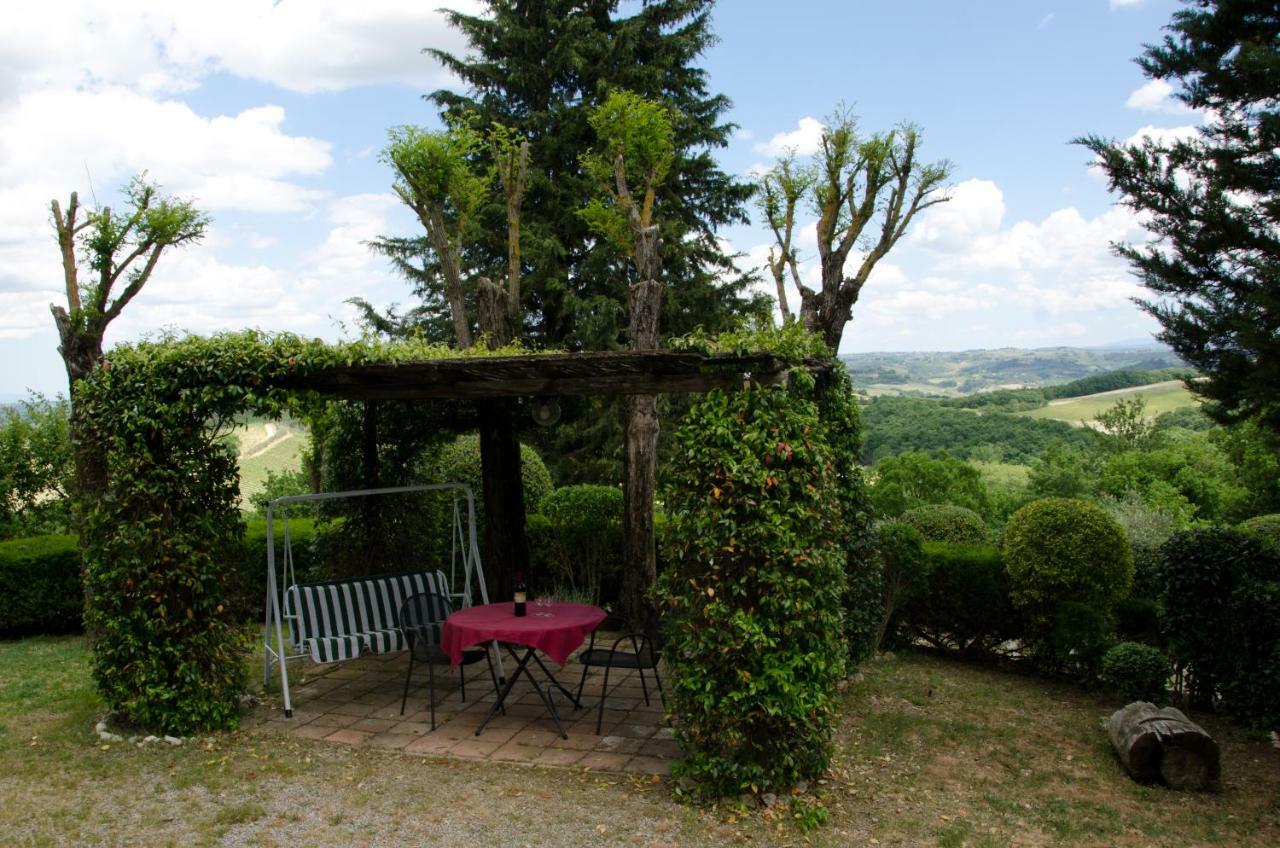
top-left (476, 400), bottom-right (527, 601)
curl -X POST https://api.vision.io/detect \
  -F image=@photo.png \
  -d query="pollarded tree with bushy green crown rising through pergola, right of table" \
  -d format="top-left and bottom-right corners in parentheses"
top-left (580, 91), bottom-right (675, 624)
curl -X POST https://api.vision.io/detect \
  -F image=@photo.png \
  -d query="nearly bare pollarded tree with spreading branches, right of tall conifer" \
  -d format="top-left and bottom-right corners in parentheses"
top-left (760, 108), bottom-right (951, 351)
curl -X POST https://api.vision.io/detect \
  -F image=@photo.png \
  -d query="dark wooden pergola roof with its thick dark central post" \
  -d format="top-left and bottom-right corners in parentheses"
top-left (282, 350), bottom-right (814, 622)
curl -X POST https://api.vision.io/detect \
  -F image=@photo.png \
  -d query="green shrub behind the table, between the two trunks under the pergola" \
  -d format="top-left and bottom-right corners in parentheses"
top-left (543, 485), bottom-right (622, 605)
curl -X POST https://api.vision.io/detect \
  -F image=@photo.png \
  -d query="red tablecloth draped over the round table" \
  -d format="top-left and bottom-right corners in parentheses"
top-left (440, 601), bottom-right (605, 666)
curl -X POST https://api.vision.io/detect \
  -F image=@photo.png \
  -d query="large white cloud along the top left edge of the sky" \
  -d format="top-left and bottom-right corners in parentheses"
top-left (0, 0), bottom-right (480, 99)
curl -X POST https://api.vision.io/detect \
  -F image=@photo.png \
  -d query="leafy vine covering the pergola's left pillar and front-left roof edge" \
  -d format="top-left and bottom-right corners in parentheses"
top-left (77, 333), bottom-right (529, 734)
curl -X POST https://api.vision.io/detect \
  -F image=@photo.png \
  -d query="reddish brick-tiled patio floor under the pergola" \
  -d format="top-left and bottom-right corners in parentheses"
top-left (246, 653), bottom-right (680, 775)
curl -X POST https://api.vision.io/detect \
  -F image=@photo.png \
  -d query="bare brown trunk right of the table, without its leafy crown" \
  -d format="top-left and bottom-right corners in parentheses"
top-left (621, 279), bottom-right (662, 628)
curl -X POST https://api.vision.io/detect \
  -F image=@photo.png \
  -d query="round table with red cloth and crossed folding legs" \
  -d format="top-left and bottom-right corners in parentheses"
top-left (440, 601), bottom-right (607, 739)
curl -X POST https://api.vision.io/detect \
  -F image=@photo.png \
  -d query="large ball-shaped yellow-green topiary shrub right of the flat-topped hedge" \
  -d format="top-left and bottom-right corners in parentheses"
top-left (1004, 498), bottom-right (1133, 671)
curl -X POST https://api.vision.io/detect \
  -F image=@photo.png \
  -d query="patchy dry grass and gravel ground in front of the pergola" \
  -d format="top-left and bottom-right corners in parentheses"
top-left (0, 638), bottom-right (1280, 848)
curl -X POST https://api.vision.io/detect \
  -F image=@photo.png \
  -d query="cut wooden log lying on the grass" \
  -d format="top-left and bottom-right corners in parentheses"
top-left (1107, 701), bottom-right (1220, 790)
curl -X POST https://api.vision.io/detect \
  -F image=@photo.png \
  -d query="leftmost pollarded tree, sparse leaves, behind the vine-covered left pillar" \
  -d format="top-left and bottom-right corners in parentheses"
top-left (49, 174), bottom-right (209, 498)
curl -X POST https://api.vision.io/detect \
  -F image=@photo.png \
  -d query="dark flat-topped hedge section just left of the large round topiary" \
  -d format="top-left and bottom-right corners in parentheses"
top-left (901, 542), bottom-right (1019, 656)
